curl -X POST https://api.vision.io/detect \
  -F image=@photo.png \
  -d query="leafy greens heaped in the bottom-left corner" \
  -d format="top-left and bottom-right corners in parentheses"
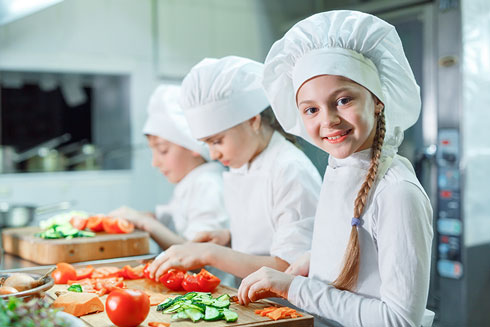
top-left (0, 297), bottom-right (70, 327)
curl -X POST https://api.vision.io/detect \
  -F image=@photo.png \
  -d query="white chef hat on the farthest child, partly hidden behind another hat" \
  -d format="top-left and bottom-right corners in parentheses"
top-left (143, 85), bottom-right (210, 160)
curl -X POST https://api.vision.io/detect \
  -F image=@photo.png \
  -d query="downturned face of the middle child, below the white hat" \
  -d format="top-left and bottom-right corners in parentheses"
top-left (202, 115), bottom-right (260, 168)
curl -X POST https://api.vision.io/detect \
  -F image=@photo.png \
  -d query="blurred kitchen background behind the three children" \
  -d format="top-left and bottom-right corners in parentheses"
top-left (0, 0), bottom-right (490, 326)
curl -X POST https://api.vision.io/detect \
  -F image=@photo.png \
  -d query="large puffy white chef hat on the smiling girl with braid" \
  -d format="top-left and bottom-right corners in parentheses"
top-left (263, 10), bottom-right (421, 148)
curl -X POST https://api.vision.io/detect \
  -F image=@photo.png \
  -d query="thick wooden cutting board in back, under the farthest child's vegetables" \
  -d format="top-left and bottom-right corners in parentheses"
top-left (2, 227), bottom-right (150, 265)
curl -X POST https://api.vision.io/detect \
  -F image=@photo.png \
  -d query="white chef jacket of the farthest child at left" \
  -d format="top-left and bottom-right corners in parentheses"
top-left (155, 162), bottom-right (229, 240)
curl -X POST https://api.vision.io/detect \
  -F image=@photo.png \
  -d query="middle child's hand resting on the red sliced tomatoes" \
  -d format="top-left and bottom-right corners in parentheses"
top-left (148, 243), bottom-right (210, 280)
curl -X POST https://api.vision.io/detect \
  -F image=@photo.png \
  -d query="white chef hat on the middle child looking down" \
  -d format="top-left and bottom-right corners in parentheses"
top-left (180, 56), bottom-right (269, 139)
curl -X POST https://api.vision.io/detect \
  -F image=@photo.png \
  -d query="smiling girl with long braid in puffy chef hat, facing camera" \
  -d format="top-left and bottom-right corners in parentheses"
top-left (238, 11), bottom-right (433, 326)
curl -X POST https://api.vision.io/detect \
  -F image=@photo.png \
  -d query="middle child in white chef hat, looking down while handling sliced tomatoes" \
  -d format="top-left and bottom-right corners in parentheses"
top-left (146, 56), bottom-right (321, 284)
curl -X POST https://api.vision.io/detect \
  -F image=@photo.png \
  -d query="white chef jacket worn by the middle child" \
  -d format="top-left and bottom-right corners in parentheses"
top-left (224, 132), bottom-right (321, 263)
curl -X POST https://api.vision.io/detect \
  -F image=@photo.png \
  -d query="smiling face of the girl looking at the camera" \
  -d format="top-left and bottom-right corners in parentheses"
top-left (296, 75), bottom-right (383, 159)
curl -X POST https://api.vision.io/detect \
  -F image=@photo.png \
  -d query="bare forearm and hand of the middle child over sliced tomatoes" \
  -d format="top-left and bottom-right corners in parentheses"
top-left (149, 243), bottom-right (289, 278)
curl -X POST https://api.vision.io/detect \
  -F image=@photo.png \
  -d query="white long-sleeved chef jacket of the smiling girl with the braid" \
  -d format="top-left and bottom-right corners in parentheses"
top-left (288, 149), bottom-right (433, 327)
